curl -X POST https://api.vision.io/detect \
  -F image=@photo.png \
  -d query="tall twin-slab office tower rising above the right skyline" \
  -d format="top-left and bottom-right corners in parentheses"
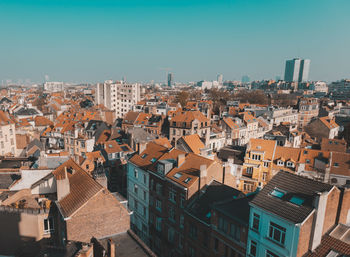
top-left (284, 58), bottom-right (310, 82)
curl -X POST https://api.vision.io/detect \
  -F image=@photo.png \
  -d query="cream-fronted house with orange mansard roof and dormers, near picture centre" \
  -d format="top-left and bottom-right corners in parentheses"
top-left (169, 111), bottom-right (210, 146)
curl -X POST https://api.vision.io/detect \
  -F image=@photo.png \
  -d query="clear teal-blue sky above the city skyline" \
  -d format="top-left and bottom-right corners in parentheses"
top-left (0, 0), bottom-right (350, 82)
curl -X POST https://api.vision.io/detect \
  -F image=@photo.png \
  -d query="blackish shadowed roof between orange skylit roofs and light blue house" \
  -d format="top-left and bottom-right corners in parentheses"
top-left (187, 181), bottom-right (245, 224)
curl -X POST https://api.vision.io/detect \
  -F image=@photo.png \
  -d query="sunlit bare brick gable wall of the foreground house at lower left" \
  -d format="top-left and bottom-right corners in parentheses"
top-left (66, 190), bottom-right (130, 242)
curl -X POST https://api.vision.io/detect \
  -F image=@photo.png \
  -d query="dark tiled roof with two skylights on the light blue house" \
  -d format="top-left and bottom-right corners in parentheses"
top-left (251, 171), bottom-right (333, 224)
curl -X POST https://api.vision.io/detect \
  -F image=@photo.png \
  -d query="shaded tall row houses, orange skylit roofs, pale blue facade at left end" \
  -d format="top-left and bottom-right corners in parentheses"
top-left (128, 142), bottom-right (233, 256)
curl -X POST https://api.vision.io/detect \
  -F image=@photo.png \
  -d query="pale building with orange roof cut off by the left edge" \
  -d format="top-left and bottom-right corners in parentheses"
top-left (0, 111), bottom-right (16, 155)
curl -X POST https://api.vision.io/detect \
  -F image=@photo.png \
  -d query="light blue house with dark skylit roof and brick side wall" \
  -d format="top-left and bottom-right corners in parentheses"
top-left (247, 171), bottom-right (341, 257)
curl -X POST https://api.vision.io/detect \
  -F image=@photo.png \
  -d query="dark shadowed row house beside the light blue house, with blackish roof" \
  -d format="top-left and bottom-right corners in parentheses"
top-left (185, 181), bottom-right (254, 257)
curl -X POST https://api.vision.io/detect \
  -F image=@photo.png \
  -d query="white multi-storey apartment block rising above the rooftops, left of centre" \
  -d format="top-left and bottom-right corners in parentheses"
top-left (95, 80), bottom-right (141, 118)
